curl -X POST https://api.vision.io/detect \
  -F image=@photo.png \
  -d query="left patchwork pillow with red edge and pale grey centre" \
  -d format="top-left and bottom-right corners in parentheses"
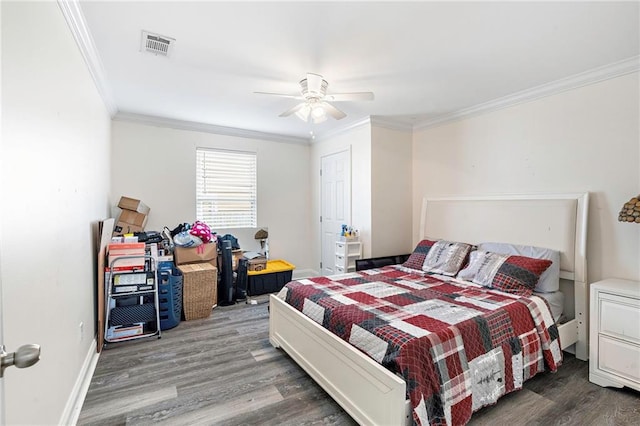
top-left (402, 240), bottom-right (471, 276)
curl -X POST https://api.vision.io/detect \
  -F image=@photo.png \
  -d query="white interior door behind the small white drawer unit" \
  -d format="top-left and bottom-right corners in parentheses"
top-left (320, 151), bottom-right (351, 275)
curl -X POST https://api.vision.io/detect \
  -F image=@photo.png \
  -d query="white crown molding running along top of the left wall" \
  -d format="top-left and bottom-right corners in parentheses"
top-left (58, 0), bottom-right (118, 117)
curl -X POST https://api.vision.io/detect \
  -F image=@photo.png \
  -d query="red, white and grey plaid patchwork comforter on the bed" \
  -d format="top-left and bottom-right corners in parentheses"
top-left (278, 266), bottom-right (562, 425)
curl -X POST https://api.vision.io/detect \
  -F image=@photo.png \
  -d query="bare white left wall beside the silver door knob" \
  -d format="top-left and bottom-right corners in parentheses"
top-left (0, 2), bottom-right (110, 424)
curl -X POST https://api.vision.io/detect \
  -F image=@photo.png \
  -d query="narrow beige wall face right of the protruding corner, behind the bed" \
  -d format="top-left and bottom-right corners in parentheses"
top-left (371, 124), bottom-right (414, 257)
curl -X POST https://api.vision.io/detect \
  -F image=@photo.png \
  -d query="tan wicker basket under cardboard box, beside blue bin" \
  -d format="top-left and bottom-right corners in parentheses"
top-left (178, 263), bottom-right (218, 321)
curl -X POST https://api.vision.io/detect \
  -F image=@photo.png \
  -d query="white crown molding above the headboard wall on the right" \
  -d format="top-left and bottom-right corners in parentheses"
top-left (413, 56), bottom-right (640, 130)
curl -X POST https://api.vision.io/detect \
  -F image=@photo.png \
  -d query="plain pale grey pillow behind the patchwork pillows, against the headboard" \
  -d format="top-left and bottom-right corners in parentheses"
top-left (478, 243), bottom-right (560, 293)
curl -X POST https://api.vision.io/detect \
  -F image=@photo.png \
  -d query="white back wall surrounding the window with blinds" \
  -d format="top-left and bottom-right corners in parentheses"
top-left (111, 121), bottom-right (313, 273)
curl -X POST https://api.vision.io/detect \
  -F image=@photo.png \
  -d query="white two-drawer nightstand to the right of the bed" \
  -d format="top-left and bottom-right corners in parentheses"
top-left (589, 278), bottom-right (640, 391)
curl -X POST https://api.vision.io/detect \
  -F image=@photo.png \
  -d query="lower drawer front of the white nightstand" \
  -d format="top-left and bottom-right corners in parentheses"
top-left (598, 336), bottom-right (640, 384)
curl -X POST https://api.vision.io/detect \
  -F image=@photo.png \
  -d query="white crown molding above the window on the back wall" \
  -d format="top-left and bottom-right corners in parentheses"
top-left (113, 111), bottom-right (309, 145)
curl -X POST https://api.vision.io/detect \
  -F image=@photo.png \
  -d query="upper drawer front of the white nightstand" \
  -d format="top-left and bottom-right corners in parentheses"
top-left (599, 292), bottom-right (640, 345)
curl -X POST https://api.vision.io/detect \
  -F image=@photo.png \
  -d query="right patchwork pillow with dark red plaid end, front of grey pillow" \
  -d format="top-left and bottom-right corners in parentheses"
top-left (457, 250), bottom-right (551, 296)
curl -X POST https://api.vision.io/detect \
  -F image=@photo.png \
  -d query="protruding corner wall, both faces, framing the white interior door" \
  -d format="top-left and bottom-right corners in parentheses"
top-left (311, 122), bottom-right (413, 259)
